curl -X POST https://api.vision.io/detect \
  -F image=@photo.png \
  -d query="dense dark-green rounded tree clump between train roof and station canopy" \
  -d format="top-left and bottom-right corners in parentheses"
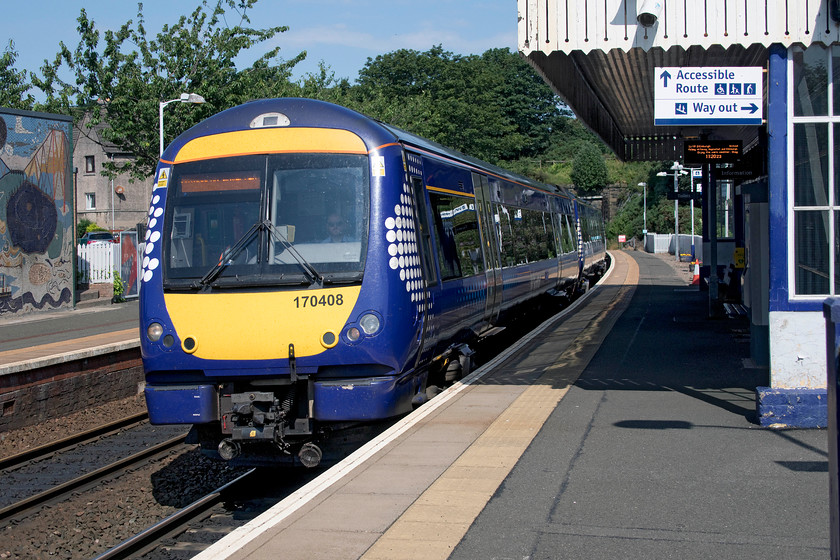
top-left (346, 45), bottom-right (563, 162)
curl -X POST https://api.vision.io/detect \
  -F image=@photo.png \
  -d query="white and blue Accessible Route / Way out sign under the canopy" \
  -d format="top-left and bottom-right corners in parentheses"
top-left (654, 66), bottom-right (764, 126)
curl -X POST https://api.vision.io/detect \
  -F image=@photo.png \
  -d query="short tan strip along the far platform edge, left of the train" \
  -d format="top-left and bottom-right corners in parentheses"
top-left (0, 328), bottom-right (140, 375)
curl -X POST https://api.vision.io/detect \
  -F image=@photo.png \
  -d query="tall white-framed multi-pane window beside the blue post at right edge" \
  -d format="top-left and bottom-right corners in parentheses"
top-left (788, 46), bottom-right (840, 296)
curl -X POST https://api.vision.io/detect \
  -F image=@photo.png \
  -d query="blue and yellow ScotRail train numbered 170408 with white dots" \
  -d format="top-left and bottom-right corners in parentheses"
top-left (140, 98), bottom-right (608, 467)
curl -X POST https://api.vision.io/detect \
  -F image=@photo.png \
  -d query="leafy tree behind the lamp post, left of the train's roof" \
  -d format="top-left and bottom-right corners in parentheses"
top-left (33, 0), bottom-right (305, 179)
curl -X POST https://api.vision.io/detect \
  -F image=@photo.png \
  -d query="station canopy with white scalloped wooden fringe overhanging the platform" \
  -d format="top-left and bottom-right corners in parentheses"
top-left (517, 0), bottom-right (840, 161)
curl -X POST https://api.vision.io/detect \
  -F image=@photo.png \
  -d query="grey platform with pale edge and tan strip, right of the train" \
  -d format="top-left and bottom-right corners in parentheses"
top-left (197, 252), bottom-right (829, 560)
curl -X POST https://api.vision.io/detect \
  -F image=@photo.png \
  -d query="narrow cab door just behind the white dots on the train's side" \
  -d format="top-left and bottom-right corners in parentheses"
top-left (410, 173), bottom-right (438, 363)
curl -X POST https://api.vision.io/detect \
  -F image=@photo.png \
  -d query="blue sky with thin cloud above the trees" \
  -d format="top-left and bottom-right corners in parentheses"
top-left (0, 0), bottom-right (517, 83)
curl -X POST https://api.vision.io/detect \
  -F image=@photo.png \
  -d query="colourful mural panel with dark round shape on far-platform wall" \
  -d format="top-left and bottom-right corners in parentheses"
top-left (0, 109), bottom-right (74, 317)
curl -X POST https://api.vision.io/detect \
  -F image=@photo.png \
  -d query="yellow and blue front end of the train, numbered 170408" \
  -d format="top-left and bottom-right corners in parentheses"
top-left (141, 108), bottom-right (425, 464)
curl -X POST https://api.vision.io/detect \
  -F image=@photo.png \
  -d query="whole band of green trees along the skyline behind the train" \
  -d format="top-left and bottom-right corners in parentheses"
top-left (13, 0), bottom-right (646, 211)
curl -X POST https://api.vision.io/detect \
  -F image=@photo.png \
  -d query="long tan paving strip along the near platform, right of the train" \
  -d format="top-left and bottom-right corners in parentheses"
top-left (362, 253), bottom-right (639, 560)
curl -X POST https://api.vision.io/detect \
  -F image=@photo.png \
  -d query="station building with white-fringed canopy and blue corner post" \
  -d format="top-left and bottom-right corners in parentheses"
top-left (518, 0), bottom-right (840, 427)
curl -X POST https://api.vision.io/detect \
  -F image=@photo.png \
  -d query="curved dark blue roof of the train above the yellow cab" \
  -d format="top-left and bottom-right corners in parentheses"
top-left (161, 97), bottom-right (576, 203)
